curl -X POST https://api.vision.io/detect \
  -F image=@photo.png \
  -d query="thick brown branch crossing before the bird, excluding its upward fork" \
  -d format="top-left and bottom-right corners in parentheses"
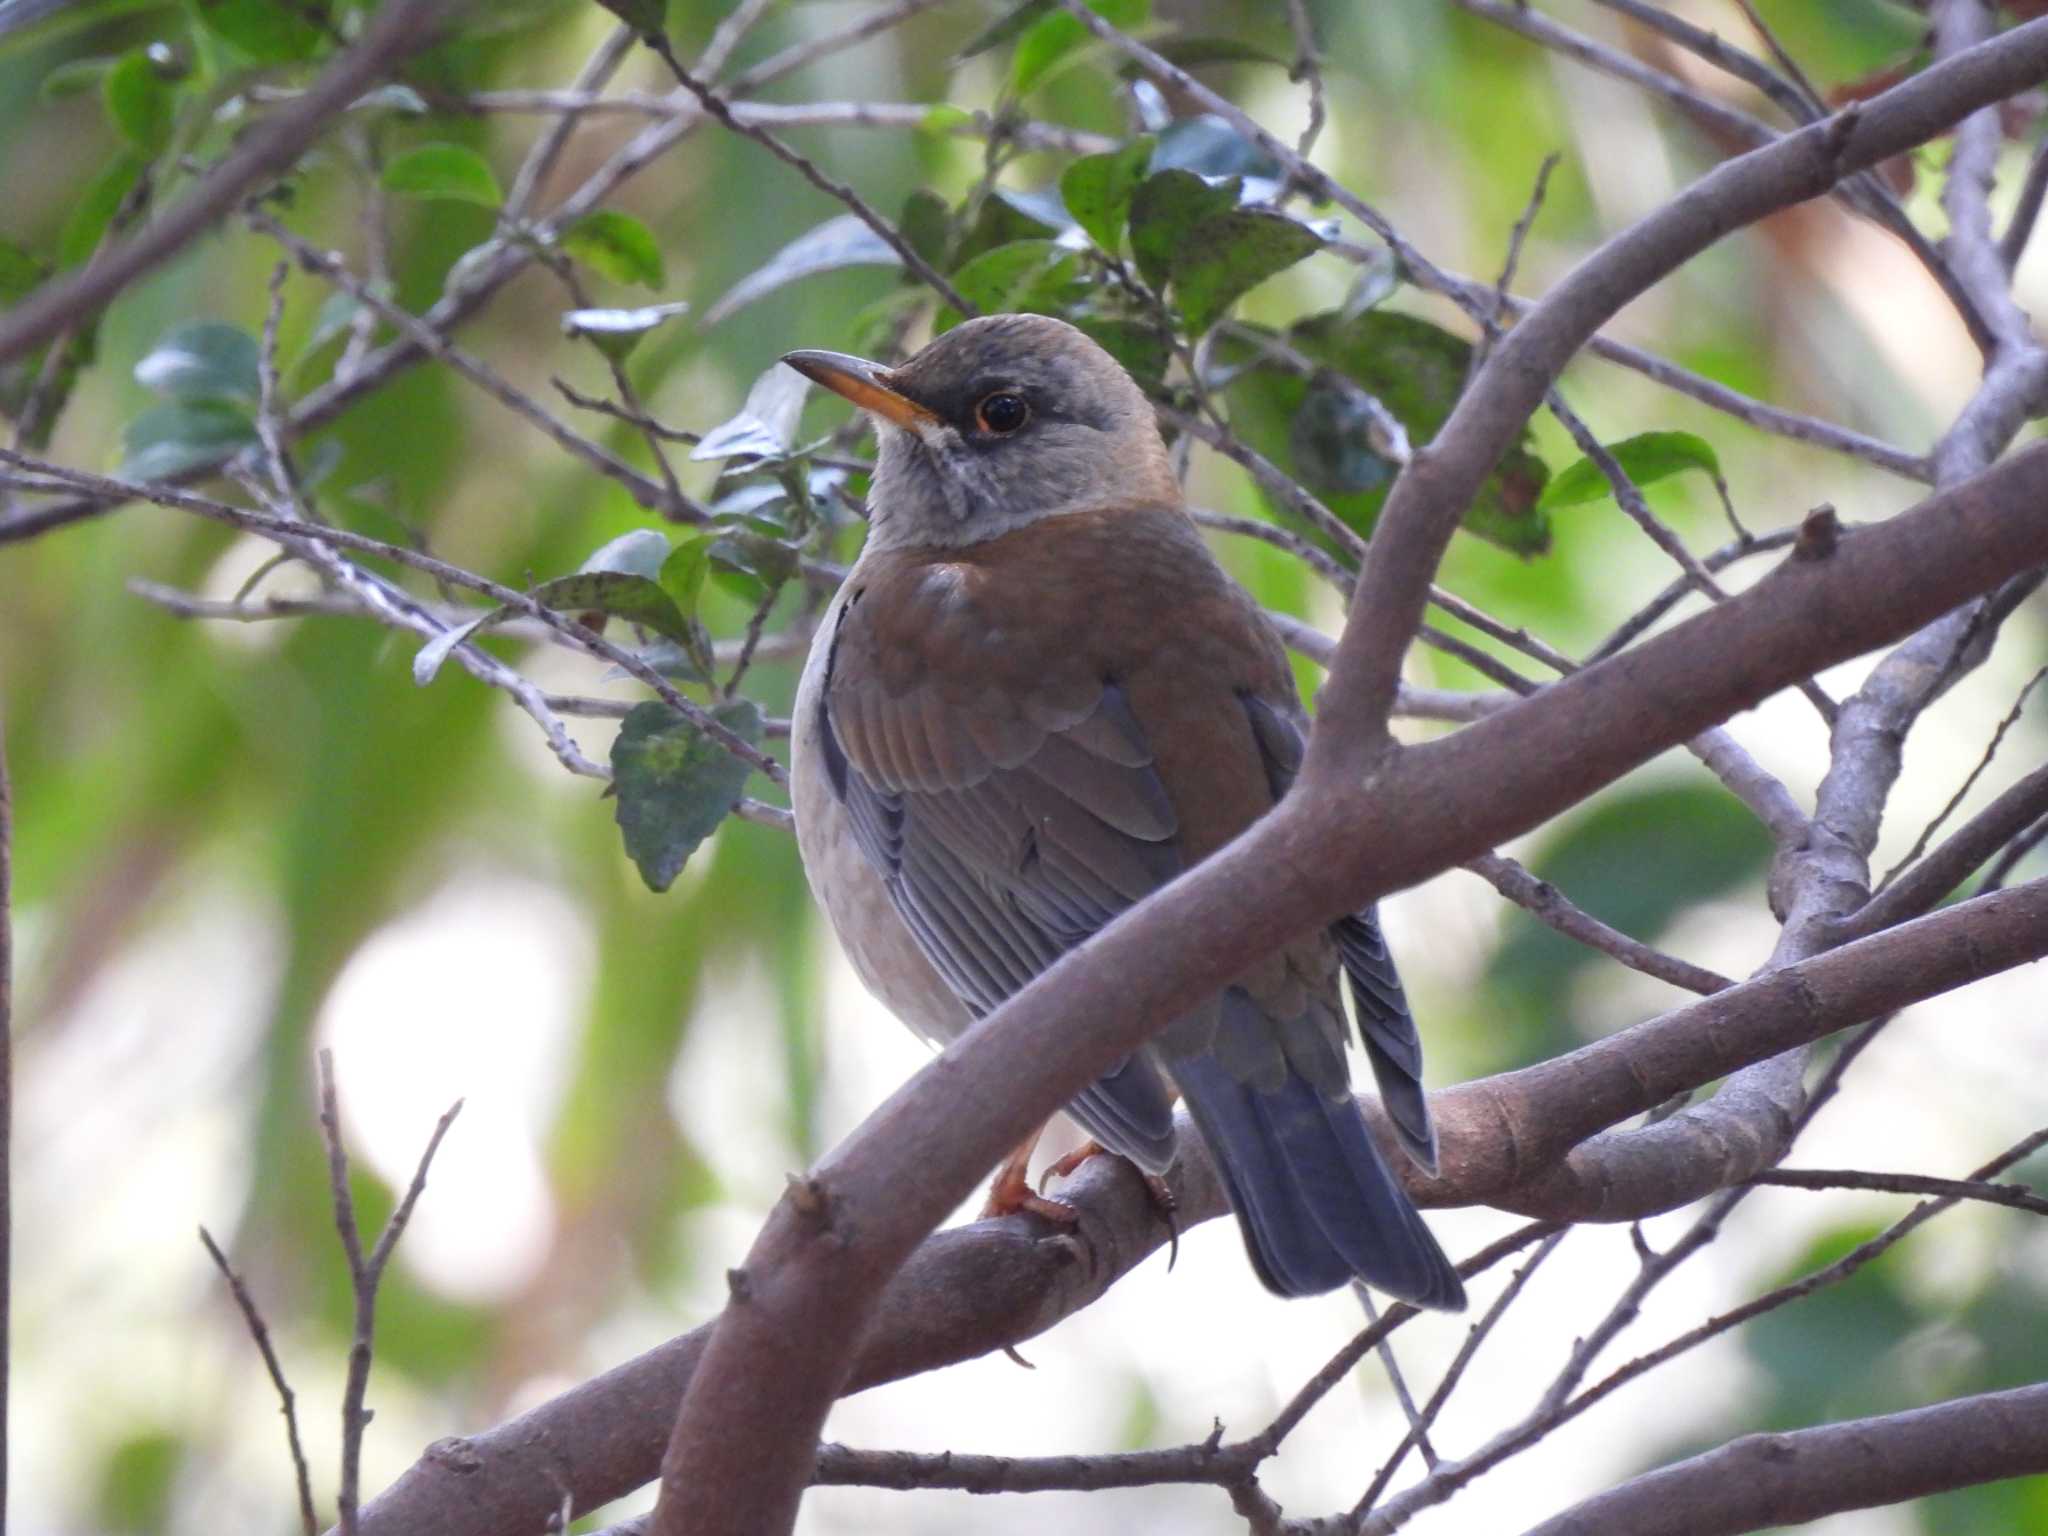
top-left (664, 415), bottom-right (2048, 1536)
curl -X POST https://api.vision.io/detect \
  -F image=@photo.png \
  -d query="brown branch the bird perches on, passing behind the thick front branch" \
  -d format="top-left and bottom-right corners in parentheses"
top-left (360, 881), bottom-right (2048, 1536)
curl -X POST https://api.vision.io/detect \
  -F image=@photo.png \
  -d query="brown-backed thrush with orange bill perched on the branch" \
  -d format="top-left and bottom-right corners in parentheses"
top-left (782, 313), bottom-right (1464, 1311)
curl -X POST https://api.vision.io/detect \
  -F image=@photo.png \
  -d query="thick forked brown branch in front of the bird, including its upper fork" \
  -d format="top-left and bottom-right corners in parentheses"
top-left (655, 20), bottom-right (2048, 1536)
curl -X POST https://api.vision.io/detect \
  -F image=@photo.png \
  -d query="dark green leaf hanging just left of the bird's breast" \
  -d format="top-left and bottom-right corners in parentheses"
top-left (612, 698), bottom-right (762, 891)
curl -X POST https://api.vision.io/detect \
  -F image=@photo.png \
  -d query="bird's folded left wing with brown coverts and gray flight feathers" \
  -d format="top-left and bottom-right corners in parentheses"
top-left (815, 573), bottom-right (1182, 1174)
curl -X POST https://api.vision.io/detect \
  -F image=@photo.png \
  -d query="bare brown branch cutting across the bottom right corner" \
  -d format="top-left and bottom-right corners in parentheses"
top-left (1528, 1384), bottom-right (2048, 1536)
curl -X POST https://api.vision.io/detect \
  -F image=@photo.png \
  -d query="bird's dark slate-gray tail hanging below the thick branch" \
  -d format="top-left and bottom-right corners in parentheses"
top-left (1171, 1057), bottom-right (1464, 1311)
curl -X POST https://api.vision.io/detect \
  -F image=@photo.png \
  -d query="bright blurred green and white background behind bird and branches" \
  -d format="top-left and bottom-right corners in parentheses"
top-left (0, 0), bottom-right (2048, 1536)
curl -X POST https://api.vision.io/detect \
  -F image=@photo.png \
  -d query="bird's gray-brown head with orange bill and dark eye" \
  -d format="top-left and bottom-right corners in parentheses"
top-left (782, 315), bottom-right (1180, 547)
